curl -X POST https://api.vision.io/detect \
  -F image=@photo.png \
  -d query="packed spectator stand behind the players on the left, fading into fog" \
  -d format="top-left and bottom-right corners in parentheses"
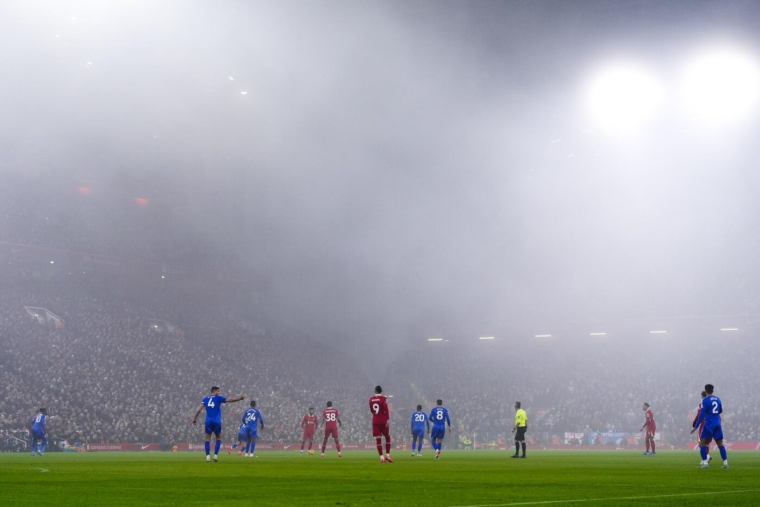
top-left (0, 280), bottom-right (367, 445)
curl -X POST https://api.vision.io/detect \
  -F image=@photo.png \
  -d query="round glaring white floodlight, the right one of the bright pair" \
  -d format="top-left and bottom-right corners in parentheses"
top-left (679, 49), bottom-right (760, 125)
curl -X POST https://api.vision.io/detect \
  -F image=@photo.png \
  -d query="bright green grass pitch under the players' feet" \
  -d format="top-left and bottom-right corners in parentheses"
top-left (0, 449), bottom-right (760, 507)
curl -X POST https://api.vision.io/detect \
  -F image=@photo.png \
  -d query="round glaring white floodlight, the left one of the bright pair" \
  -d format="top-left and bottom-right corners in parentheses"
top-left (588, 64), bottom-right (663, 130)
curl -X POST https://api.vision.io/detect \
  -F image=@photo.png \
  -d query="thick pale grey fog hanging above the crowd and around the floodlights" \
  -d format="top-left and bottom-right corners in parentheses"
top-left (0, 1), bottom-right (760, 452)
